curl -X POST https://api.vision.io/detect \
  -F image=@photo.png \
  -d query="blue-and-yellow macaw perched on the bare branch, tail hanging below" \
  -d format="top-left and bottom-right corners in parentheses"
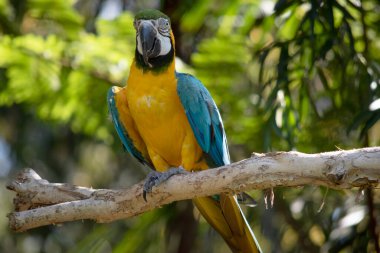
top-left (107, 10), bottom-right (261, 252)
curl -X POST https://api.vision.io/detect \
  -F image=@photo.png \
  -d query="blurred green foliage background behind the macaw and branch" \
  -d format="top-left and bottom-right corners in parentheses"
top-left (0, 0), bottom-right (380, 252)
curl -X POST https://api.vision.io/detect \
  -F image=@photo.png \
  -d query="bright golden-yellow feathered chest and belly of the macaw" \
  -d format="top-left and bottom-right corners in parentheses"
top-left (126, 62), bottom-right (192, 166)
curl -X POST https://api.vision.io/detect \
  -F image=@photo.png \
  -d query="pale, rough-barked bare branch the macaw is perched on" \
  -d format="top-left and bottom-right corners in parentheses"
top-left (7, 147), bottom-right (380, 231)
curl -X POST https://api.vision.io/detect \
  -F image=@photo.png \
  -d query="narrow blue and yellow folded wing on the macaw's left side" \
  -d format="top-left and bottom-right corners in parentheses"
top-left (107, 86), bottom-right (154, 169)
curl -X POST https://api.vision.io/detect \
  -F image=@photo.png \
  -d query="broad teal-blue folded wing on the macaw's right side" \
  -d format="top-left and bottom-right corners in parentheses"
top-left (176, 73), bottom-right (230, 167)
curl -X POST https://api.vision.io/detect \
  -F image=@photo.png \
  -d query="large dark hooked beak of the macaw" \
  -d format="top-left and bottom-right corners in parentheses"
top-left (138, 23), bottom-right (161, 67)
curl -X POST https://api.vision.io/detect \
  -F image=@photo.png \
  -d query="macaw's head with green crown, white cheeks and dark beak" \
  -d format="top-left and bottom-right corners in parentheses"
top-left (133, 9), bottom-right (174, 70)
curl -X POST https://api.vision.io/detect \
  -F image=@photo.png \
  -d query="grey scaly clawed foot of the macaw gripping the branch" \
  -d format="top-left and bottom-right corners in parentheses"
top-left (143, 166), bottom-right (188, 201)
